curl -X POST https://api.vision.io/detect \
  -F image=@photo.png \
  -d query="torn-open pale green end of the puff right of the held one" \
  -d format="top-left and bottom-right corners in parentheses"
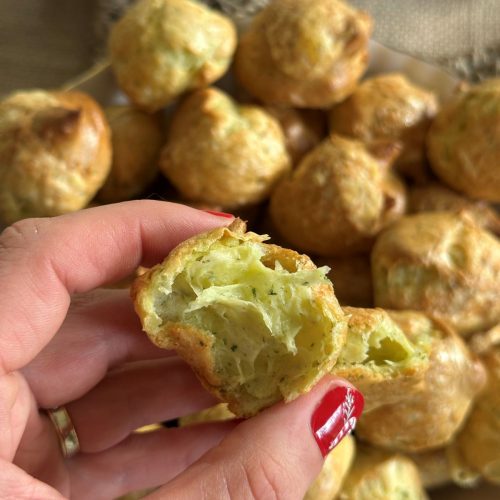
top-left (332, 307), bottom-right (433, 412)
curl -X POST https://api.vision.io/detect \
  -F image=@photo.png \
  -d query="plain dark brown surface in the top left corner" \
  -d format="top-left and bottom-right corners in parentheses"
top-left (0, 0), bottom-right (95, 95)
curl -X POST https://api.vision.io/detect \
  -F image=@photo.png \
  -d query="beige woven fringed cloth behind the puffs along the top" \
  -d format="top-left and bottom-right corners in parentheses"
top-left (97, 0), bottom-right (500, 80)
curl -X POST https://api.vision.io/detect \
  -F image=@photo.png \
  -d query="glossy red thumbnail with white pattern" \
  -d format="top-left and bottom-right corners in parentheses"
top-left (311, 386), bottom-right (365, 456)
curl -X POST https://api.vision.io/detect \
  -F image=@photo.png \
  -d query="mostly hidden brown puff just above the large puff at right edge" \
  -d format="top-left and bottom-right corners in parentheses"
top-left (408, 182), bottom-right (500, 234)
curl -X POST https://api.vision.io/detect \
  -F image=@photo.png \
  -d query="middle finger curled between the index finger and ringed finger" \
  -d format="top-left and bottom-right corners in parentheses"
top-left (22, 290), bottom-right (172, 408)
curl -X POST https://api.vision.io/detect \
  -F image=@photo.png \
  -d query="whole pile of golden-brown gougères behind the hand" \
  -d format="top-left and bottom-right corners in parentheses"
top-left (0, 0), bottom-right (500, 500)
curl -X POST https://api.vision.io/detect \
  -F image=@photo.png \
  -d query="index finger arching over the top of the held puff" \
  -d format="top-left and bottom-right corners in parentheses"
top-left (0, 200), bottom-right (230, 373)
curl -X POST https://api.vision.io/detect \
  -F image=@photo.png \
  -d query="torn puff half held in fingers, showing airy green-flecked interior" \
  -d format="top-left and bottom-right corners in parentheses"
top-left (135, 224), bottom-right (346, 415)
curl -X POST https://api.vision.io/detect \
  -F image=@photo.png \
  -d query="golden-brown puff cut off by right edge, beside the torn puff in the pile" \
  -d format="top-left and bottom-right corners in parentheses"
top-left (456, 347), bottom-right (500, 484)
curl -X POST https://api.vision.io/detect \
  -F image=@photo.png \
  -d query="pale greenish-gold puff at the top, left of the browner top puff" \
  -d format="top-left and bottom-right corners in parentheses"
top-left (109, 0), bottom-right (236, 111)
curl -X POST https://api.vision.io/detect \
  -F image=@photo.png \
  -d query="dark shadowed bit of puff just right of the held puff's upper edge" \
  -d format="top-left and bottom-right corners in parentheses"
top-left (315, 255), bottom-right (373, 307)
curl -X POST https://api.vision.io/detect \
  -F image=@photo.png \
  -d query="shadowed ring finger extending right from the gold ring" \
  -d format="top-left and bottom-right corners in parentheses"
top-left (66, 357), bottom-right (216, 453)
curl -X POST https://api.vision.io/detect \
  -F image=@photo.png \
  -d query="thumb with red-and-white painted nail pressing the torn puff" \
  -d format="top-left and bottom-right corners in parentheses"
top-left (148, 376), bottom-right (363, 500)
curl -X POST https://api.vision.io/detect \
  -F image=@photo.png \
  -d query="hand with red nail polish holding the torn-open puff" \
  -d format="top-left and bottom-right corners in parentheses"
top-left (0, 201), bottom-right (363, 500)
